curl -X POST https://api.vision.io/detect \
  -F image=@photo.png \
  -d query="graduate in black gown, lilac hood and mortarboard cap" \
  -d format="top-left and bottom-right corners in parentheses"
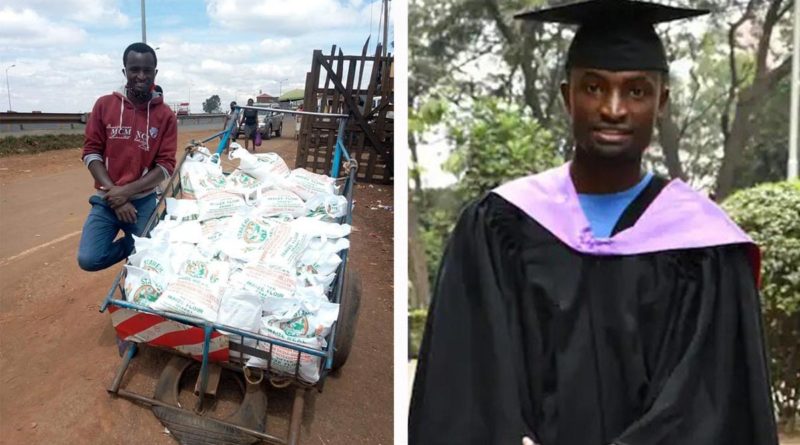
top-left (409, 0), bottom-right (777, 445)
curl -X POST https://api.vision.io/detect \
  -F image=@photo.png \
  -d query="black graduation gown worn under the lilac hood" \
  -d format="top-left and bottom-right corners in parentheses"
top-left (409, 186), bottom-right (777, 445)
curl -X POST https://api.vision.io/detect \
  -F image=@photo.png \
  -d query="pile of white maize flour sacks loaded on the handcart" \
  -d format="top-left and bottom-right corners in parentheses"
top-left (125, 143), bottom-right (350, 383)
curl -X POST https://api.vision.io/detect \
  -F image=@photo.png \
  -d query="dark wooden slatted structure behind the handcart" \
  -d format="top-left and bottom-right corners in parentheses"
top-left (296, 40), bottom-right (394, 184)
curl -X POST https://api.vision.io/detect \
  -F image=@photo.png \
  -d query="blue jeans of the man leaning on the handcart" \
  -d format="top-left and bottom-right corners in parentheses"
top-left (78, 193), bottom-right (158, 272)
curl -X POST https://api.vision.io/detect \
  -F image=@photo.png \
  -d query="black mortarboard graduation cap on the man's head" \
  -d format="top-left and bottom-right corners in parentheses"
top-left (514, 0), bottom-right (710, 72)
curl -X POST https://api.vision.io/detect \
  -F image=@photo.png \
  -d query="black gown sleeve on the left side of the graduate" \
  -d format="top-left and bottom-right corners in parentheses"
top-left (409, 199), bottom-right (531, 445)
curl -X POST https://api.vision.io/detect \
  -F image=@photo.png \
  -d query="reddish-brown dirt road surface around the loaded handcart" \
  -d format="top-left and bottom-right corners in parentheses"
top-left (0, 131), bottom-right (393, 444)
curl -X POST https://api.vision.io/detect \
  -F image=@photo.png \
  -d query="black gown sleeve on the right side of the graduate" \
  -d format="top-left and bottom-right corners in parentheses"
top-left (614, 245), bottom-right (778, 445)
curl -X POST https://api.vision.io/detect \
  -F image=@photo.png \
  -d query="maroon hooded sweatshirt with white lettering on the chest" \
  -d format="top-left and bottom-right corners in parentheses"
top-left (82, 88), bottom-right (178, 199)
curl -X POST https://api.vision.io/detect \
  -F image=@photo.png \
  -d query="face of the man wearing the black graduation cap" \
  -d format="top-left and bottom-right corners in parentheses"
top-left (561, 68), bottom-right (669, 159)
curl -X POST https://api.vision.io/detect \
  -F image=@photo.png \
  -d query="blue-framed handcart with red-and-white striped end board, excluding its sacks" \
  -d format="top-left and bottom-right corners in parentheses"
top-left (100, 106), bottom-right (361, 444)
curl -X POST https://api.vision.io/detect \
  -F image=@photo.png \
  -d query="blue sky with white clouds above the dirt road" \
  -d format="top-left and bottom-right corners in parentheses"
top-left (0, 0), bottom-right (394, 113)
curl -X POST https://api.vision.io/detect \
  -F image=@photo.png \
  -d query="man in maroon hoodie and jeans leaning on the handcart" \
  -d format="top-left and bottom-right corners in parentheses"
top-left (78, 43), bottom-right (178, 271)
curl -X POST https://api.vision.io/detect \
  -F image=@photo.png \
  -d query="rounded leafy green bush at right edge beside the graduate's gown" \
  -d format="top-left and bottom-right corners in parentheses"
top-left (723, 181), bottom-right (800, 432)
